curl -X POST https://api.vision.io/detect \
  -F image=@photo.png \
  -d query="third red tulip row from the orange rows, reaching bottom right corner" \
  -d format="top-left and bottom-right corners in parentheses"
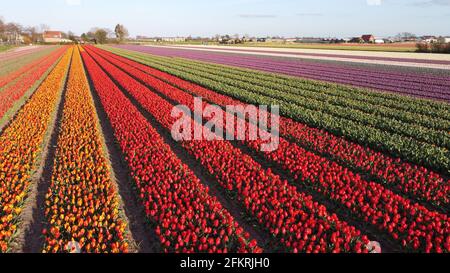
top-left (87, 45), bottom-right (450, 252)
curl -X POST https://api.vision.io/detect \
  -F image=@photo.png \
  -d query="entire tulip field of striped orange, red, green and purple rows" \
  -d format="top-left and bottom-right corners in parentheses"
top-left (0, 45), bottom-right (450, 253)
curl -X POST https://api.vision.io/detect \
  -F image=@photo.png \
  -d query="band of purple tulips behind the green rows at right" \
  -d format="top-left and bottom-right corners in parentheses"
top-left (115, 46), bottom-right (450, 101)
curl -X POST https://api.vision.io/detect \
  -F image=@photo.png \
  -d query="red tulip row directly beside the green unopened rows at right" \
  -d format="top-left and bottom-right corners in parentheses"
top-left (96, 49), bottom-right (450, 207)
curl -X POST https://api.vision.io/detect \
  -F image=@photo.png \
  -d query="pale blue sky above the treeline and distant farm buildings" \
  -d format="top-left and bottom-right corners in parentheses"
top-left (0, 0), bottom-right (450, 37)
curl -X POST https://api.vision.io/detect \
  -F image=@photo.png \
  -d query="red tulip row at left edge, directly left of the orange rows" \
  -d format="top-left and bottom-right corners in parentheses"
top-left (0, 48), bottom-right (66, 120)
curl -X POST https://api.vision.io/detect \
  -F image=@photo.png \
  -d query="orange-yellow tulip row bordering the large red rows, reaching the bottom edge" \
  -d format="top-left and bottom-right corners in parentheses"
top-left (43, 48), bottom-right (128, 253)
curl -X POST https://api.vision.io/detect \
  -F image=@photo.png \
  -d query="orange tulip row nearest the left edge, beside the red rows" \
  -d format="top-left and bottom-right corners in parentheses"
top-left (0, 45), bottom-right (72, 252)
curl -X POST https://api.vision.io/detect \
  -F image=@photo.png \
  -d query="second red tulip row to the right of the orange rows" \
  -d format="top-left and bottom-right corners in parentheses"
top-left (84, 48), bottom-right (369, 252)
